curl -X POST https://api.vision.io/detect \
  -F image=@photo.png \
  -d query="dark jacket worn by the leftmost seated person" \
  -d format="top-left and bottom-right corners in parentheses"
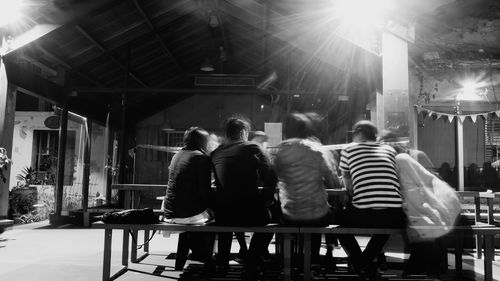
top-left (164, 149), bottom-right (212, 218)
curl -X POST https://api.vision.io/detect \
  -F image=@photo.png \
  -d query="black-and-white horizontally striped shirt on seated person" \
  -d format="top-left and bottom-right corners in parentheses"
top-left (340, 142), bottom-right (402, 209)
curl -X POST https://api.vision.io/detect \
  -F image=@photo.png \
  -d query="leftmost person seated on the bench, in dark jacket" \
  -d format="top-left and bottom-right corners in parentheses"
top-left (163, 127), bottom-right (214, 269)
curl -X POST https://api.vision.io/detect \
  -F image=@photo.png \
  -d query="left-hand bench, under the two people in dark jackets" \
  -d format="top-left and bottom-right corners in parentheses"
top-left (92, 222), bottom-right (299, 281)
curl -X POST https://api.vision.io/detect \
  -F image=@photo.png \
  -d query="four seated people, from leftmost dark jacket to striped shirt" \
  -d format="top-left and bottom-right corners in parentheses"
top-left (162, 113), bottom-right (434, 280)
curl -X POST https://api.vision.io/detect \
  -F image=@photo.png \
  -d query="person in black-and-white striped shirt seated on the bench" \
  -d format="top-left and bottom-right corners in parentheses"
top-left (339, 120), bottom-right (405, 280)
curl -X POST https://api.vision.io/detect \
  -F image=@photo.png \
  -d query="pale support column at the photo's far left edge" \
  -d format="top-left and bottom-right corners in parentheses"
top-left (0, 58), bottom-right (16, 219)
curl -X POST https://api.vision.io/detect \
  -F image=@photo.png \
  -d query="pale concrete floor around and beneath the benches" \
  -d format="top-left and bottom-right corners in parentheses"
top-left (0, 222), bottom-right (500, 281)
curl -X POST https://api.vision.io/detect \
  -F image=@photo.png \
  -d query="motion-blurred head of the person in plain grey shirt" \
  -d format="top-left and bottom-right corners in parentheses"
top-left (283, 112), bottom-right (321, 139)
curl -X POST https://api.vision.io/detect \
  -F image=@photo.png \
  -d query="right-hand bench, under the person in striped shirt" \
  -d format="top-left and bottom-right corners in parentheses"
top-left (300, 224), bottom-right (500, 281)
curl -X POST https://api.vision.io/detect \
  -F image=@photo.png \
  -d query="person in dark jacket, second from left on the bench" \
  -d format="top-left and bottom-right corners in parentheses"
top-left (211, 117), bottom-right (277, 280)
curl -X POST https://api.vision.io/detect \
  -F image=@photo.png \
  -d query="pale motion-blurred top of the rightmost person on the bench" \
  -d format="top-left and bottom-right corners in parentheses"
top-left (396, 153), bottom-right (460, 242)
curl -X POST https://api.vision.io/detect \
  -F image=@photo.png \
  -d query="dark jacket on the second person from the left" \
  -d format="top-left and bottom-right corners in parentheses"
top-left (211, 141), bottom-right (277, 225)
